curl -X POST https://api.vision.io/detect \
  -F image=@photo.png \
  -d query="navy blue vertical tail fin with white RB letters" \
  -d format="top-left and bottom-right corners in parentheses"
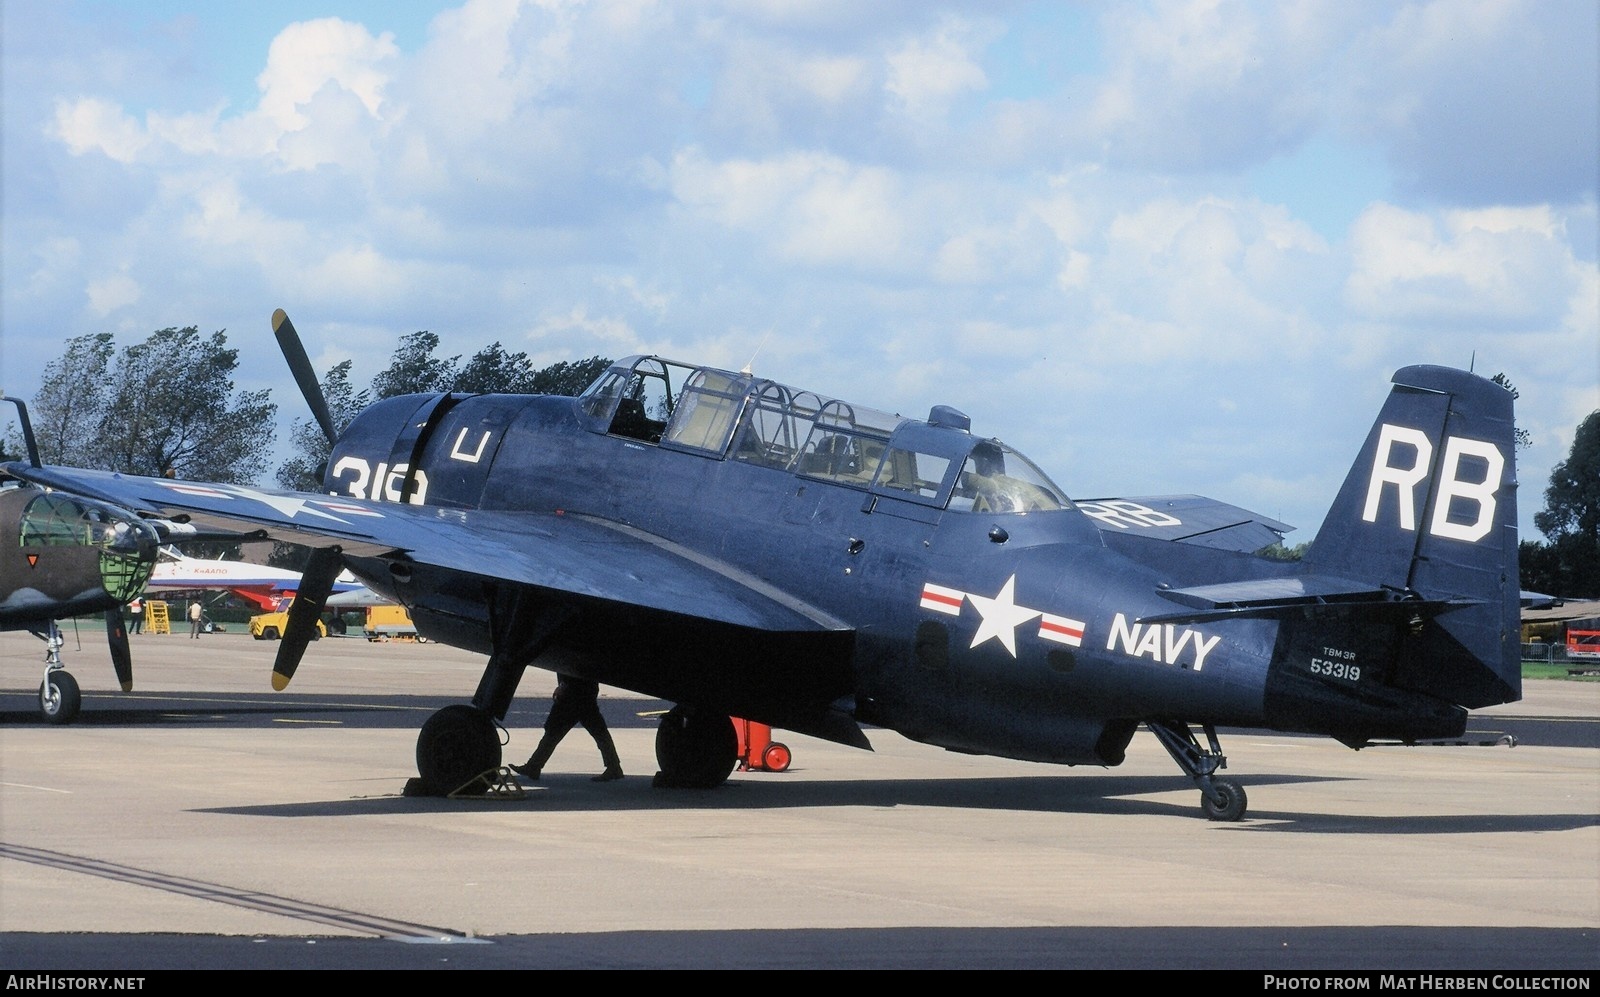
top-left (1304, 366), bottom-right (1522, 709)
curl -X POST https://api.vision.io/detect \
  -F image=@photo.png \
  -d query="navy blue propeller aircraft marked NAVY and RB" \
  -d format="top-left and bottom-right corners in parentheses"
top-left (6, 310), bottom-right (1522, 821)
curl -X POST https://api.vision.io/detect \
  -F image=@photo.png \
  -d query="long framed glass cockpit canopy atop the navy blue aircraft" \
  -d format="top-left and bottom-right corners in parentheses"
top-left (576, 357), bottom-right (1072, 514)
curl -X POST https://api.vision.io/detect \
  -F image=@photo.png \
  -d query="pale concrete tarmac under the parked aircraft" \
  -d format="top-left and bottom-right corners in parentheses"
top-left (0, 627), bottom-right (1600, 975)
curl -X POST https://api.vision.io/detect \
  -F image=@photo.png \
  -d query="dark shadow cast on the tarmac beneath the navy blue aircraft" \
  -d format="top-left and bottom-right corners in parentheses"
top-left (198, 773), bottom-right (1600, 835)
